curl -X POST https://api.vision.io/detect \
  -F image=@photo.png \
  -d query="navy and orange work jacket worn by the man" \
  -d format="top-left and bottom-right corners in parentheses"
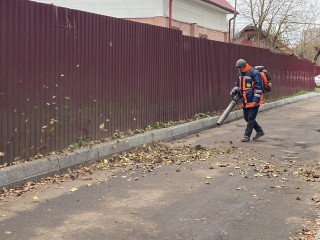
top-left (236, 64), bottom-right (263, 108)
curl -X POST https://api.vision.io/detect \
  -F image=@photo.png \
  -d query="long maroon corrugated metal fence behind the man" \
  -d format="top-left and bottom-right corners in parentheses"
top-left (0, 0), bottom-right (315, 164)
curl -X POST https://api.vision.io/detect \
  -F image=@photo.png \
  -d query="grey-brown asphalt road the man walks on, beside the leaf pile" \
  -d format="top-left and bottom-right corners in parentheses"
top-left (0, 94), bottom-right (320, 240)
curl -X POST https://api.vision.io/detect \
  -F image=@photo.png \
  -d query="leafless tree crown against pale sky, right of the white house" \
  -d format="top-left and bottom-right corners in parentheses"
top-left (238, 0), bottom-right (319, 46)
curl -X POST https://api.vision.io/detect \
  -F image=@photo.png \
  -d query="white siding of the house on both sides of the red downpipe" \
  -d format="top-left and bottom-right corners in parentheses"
top-left (33, 0), bottom-right (228, 32)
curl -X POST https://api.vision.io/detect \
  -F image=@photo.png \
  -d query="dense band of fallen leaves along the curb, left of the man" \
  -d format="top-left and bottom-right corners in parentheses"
top-left (0, 142), bottom-right (235, 202)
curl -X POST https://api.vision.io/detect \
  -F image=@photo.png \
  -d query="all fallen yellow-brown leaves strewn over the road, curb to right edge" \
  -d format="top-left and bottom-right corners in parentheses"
top-left (0, 142), bottom-right (320, 240)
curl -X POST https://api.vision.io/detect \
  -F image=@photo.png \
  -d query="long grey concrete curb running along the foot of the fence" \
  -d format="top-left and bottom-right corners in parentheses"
top-left (0, 93), bottom-right (320, 189)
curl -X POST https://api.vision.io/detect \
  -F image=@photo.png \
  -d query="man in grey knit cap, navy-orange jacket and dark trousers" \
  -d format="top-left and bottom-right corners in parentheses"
top-left (230, 59), bottom-right (264, 142)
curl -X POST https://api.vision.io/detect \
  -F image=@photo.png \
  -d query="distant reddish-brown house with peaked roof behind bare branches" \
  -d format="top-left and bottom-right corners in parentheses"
top-left (234, 25), bottom-right (292, 55)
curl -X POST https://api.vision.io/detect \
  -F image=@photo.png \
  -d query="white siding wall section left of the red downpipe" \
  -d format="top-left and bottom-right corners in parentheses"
top-left (32, 0), bottom-right (163, 18)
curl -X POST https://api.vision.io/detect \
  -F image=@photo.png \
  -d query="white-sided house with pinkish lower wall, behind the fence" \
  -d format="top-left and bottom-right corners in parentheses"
top-left (33, 0), bottom-right (234, 42)
